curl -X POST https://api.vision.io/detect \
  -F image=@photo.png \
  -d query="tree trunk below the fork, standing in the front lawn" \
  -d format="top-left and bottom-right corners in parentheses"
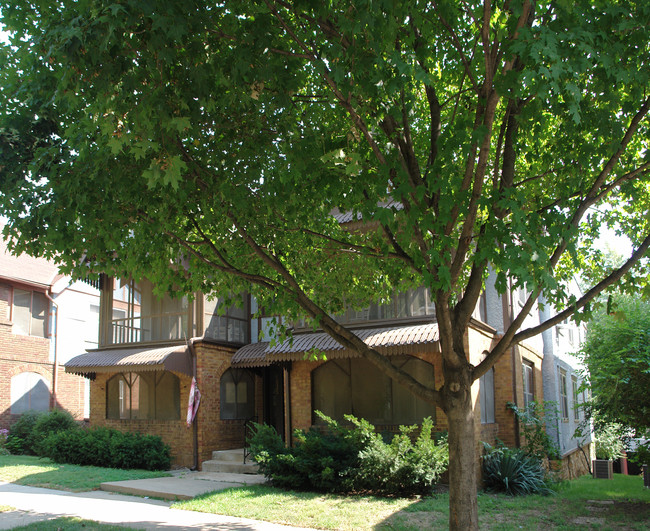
top-left (444, 366), bottom-right (478, 531)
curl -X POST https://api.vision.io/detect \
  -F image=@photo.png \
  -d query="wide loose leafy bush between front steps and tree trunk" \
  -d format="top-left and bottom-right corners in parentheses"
top-left (250, 412), bottom-right (449, 496)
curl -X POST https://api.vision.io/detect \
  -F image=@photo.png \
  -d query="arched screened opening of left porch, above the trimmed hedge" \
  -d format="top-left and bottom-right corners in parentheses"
top-left (106, 371), bottom-right (181, 420)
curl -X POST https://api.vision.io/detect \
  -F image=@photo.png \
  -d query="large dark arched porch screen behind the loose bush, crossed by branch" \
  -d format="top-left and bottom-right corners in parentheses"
top-left (312, 356), bottom-right (436, 425)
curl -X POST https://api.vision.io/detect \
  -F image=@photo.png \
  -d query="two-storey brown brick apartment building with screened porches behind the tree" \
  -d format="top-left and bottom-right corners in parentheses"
top-left (66, 270), bottom-right (582, 474)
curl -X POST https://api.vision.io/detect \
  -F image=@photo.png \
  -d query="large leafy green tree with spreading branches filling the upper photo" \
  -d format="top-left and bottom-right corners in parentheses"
top-left (0, 0), bottom-right (650, 529)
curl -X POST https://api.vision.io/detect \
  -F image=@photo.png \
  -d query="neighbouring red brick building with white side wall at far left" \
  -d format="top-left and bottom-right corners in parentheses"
top-left (0, 240), bottom-right (99, 428)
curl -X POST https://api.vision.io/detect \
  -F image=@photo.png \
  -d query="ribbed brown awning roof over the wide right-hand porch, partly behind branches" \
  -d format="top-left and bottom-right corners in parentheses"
top-left (231, 323), bottom-right (439, 367)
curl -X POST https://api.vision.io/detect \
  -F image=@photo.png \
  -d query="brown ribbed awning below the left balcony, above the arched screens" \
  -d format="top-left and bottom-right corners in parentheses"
top-left (65, 345), bottom-right (192, 376)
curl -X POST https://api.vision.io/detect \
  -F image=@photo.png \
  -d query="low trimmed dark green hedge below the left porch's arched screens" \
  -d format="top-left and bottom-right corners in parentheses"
top-left (44, 428), bottom-right (171, 470)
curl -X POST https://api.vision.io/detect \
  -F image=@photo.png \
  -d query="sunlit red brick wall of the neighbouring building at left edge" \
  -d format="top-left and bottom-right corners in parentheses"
top-left (0, 284), bottom-right (85, 428)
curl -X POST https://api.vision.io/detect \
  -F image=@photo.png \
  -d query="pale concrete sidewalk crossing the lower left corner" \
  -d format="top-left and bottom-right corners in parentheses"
top-left (0, 478), bottom-right (314, 531)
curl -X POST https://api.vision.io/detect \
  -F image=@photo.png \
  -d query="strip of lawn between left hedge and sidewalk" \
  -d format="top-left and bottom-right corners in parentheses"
top-left (0, 455), bottom-right (169, 492)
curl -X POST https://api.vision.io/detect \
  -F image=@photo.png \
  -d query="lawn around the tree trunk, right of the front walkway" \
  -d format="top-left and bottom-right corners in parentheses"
top-left (173, 475), bottom-right (650, 531)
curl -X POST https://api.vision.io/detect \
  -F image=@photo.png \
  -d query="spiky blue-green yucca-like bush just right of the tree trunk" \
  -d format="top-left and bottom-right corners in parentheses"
top-left (483, 443), bottom-right (553, 496)
